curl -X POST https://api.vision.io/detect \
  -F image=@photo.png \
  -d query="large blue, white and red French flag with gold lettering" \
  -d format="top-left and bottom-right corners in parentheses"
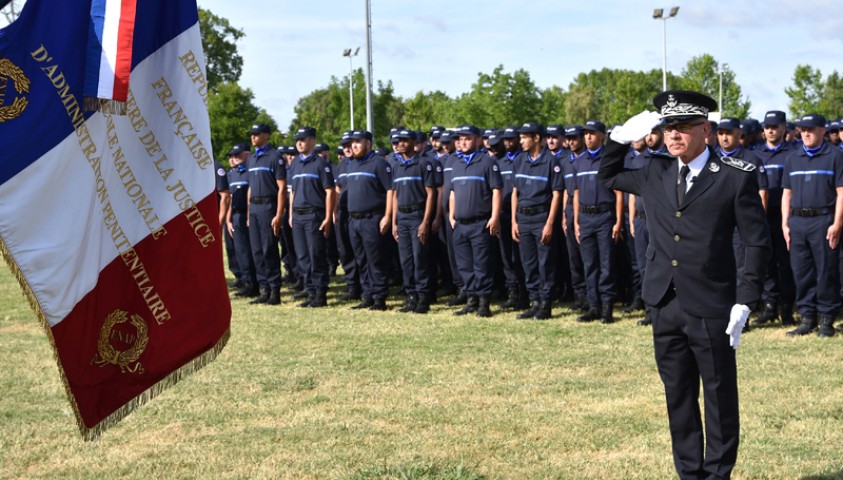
top-left (0, 0), bottom-right (231, 438)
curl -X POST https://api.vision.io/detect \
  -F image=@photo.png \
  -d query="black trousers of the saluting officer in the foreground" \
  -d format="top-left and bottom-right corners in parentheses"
top-left (651, 288), bottom-right (740, 479)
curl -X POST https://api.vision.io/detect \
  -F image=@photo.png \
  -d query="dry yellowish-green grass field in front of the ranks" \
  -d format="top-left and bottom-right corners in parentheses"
top-left (0, 268), bottom-right (843, 480)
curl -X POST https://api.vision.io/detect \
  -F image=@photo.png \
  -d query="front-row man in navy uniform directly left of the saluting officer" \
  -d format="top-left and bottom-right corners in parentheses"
top-left (574, 120), bottom-right (623, 323)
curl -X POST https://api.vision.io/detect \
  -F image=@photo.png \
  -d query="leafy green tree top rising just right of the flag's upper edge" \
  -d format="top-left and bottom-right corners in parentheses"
top-left (199, 8), bottom-right (245, 90)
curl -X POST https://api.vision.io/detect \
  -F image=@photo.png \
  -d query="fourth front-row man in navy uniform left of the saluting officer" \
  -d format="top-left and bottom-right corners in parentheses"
top-left (392, 129), bottom-right (440, 313)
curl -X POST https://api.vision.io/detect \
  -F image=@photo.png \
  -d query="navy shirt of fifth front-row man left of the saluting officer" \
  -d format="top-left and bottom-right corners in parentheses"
top-left (346, 152), bottom-right (392, 213)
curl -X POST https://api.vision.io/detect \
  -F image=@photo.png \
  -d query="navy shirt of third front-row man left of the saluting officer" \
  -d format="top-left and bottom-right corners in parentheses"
top-left (451, 152), bottom-right (503, 220)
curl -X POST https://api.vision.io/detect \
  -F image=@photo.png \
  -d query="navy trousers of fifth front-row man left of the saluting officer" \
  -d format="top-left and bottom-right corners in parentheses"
top-left (348, 215), bottom-right (392, 301)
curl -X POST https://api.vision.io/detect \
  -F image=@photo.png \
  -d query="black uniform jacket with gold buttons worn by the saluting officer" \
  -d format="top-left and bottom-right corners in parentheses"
top-left (599, 141), bottom-right (770, 318)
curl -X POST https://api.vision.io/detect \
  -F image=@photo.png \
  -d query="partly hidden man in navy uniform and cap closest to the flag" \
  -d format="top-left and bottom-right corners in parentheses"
top-left (225, 143), bottom-right (260, 297)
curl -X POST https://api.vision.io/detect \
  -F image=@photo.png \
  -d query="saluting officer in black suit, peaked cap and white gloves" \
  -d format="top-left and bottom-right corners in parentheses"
top-left (600, 90), bottom-right (770, 478)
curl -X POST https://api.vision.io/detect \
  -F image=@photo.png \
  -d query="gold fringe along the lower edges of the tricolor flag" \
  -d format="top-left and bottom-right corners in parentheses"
top-left (0, 237), bottom-right (231, 441)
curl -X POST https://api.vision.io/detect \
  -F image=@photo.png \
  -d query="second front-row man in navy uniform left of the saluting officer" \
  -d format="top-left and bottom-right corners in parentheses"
top-left (512, 122), bottom-right (565, 320)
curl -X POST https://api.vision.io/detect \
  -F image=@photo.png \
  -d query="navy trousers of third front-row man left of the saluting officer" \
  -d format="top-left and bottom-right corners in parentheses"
top-left (454, 219), bottom-right (494, 296)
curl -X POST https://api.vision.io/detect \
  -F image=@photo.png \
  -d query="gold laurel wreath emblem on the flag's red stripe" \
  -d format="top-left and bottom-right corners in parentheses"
top-left (92, 310), bottom-right (149, 374)
